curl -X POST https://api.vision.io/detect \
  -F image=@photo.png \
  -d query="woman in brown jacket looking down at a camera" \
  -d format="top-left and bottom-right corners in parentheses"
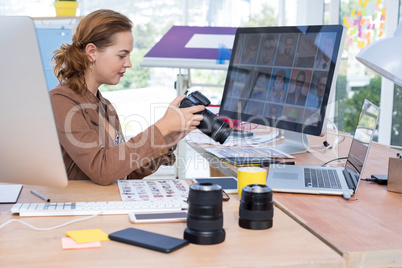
top-left (50, 10), bottom-right (205, 185)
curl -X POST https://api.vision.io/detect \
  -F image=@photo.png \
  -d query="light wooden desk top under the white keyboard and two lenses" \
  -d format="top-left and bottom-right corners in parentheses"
top-left (0, 181), bottom-right (344, 268)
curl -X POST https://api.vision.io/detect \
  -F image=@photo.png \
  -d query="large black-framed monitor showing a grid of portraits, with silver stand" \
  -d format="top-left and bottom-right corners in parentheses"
top-left (219, 25), bottom-right (346, 153)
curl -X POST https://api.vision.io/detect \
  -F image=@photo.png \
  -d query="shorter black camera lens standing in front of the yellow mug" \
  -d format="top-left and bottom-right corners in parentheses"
top-left (239, 184), bottom-right (274, 230)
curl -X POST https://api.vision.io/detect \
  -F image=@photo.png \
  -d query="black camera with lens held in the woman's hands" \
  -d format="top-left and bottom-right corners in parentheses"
top-left (179, 91), bottom-right (232, 144)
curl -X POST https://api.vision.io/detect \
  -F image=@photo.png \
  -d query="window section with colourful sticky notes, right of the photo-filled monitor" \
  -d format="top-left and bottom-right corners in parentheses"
top-left (335, 0), bottom-right (385, 138)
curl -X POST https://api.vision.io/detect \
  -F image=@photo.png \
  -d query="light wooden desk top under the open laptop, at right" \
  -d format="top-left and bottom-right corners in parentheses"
top-left (190, 133), bottom-right (402, 267)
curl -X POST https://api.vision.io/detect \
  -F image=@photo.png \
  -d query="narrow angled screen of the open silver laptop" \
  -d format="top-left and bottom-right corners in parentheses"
top-left (345, 100), bottom-right (380, 191)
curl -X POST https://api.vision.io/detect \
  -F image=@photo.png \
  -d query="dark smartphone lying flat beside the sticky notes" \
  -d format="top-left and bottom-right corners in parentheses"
top-left (109, 228), bottom-right (189, 253)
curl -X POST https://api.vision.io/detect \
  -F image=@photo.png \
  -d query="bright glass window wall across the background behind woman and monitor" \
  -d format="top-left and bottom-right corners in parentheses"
top-left (0, 0), bottom-right (402, 145)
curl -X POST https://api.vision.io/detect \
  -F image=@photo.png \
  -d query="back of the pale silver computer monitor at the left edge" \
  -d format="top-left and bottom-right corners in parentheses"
top-left (0, 16), bottom-right (68, 187)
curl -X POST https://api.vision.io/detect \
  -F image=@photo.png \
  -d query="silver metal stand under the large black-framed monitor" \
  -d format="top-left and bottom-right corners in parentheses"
top-left (273, 130), bottom-right (309, 154)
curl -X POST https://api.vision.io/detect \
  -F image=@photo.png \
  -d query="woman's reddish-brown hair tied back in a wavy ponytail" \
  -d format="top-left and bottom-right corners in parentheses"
top-left (52, 9), bottom-right (133, 93)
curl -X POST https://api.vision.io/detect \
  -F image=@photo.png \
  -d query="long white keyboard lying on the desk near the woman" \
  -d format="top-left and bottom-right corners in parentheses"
top-left (10, 198), bottom-right (188, 216)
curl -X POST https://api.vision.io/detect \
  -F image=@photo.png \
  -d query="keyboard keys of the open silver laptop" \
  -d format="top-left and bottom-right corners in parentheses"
top-left (304, 168), bottom-right (341, 189)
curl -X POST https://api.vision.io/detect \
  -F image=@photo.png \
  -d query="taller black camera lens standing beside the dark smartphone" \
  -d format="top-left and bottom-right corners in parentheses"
top-left (184, 183), bottom-right (225, 245)
